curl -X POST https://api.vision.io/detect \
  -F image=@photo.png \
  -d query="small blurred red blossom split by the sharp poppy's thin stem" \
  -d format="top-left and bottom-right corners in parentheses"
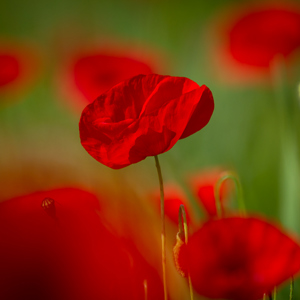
top-left (152, 184), bottom-right (190, 226)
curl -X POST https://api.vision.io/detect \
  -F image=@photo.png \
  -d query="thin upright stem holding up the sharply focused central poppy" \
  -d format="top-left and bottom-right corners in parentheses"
top-left (154, 155), bottom-right (168, 300)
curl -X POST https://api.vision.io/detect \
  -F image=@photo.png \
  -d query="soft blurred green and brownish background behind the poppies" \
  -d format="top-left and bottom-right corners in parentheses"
top-left (0, 0), bottom-right (300, 299)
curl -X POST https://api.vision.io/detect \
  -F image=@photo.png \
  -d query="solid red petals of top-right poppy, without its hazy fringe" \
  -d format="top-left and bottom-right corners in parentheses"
top-left (229, 4), bottom-right (300, 67)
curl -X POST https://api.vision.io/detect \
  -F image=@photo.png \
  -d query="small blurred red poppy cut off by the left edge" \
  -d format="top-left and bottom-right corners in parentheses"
top-left (0, 41), bottom-right (38, 94)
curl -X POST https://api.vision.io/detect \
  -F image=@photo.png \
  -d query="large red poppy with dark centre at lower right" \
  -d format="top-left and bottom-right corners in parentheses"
top-left (177, 217), bottom-right (300, 300)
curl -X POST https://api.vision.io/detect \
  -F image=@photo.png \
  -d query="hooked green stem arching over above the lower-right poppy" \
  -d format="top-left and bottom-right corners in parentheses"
top-left (214, 172), bottom-right (246, 218)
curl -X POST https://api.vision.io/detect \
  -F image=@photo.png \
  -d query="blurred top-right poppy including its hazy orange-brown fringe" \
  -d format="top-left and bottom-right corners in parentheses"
top-left (210, 2), bottom-right (300, 82)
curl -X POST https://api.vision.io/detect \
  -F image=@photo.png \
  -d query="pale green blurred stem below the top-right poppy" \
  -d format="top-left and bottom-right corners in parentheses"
top-left (271, 57), bottom-right (300, 232)
